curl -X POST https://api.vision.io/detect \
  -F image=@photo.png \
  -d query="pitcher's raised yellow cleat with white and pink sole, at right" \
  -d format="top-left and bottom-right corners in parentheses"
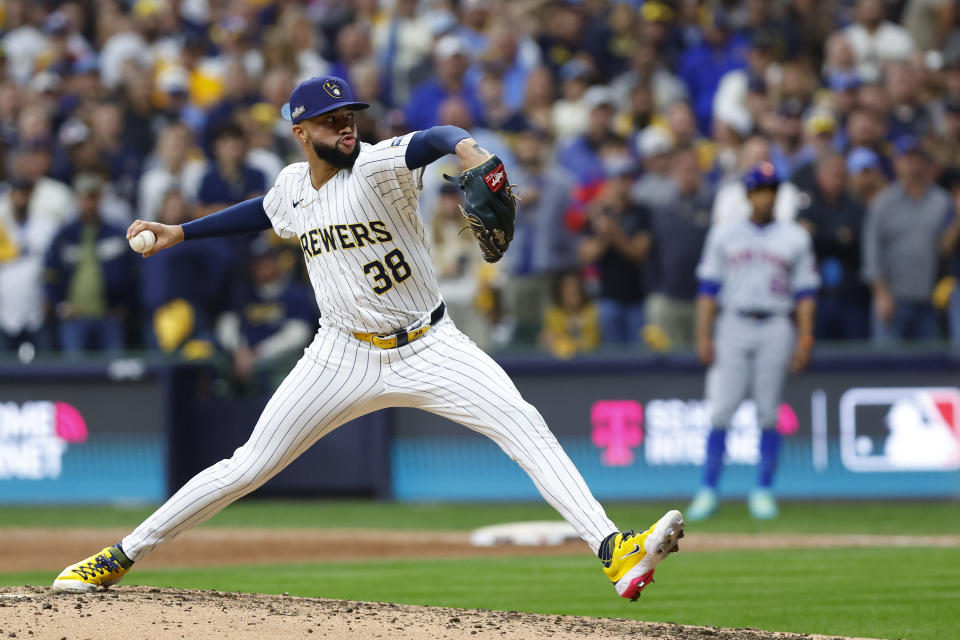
top-left (597, 509), bottom-right (683, 601)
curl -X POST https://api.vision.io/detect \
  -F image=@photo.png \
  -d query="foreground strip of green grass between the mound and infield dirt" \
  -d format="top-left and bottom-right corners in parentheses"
top-left (9, 548), bottom-right (960, 640)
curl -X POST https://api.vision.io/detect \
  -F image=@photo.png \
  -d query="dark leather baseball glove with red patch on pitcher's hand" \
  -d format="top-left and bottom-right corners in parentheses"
top-left (444, 156), bottom-right (519, 262)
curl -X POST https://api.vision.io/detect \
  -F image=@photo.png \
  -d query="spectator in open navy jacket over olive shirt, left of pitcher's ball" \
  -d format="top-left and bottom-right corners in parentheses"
top-left (44, 173), bottom-right (137, 355)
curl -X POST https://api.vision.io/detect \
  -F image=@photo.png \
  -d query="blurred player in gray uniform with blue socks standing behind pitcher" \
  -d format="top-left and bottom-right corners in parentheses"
top-left (687, 162), bottom-right (820, 520)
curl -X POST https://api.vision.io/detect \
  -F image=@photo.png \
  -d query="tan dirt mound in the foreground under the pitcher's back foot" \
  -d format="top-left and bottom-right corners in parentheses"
top-left (0, 586), bottom-right (876, 640)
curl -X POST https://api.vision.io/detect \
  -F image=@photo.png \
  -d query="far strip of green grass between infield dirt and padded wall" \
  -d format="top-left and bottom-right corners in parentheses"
top-left (0, 500), bottom-right (960, 534)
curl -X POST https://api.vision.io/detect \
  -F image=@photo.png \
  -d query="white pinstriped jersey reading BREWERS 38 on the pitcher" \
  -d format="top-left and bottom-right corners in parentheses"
top-left (263, 133), bottom-right (440, 335)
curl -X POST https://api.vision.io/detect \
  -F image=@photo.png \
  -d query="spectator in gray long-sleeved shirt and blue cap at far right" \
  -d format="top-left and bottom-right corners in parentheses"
top-left (863, 136), bottom-right (953, 344)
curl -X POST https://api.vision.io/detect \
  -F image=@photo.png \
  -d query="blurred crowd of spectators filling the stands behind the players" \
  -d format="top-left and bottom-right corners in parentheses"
top-left (0, 0), bottom-right (960, 370)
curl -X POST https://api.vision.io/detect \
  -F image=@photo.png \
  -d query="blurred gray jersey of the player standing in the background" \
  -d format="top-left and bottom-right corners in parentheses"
top-left (697, 221), bottom-right (820, 314)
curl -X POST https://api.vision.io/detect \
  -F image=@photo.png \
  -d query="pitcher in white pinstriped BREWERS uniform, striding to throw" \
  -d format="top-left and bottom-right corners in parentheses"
top-left (53, 76), bottom-right (683, 600)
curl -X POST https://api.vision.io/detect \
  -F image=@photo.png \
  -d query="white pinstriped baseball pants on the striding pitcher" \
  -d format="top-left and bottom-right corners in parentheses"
top-left (122, 319), bottom-right (617, 560)
